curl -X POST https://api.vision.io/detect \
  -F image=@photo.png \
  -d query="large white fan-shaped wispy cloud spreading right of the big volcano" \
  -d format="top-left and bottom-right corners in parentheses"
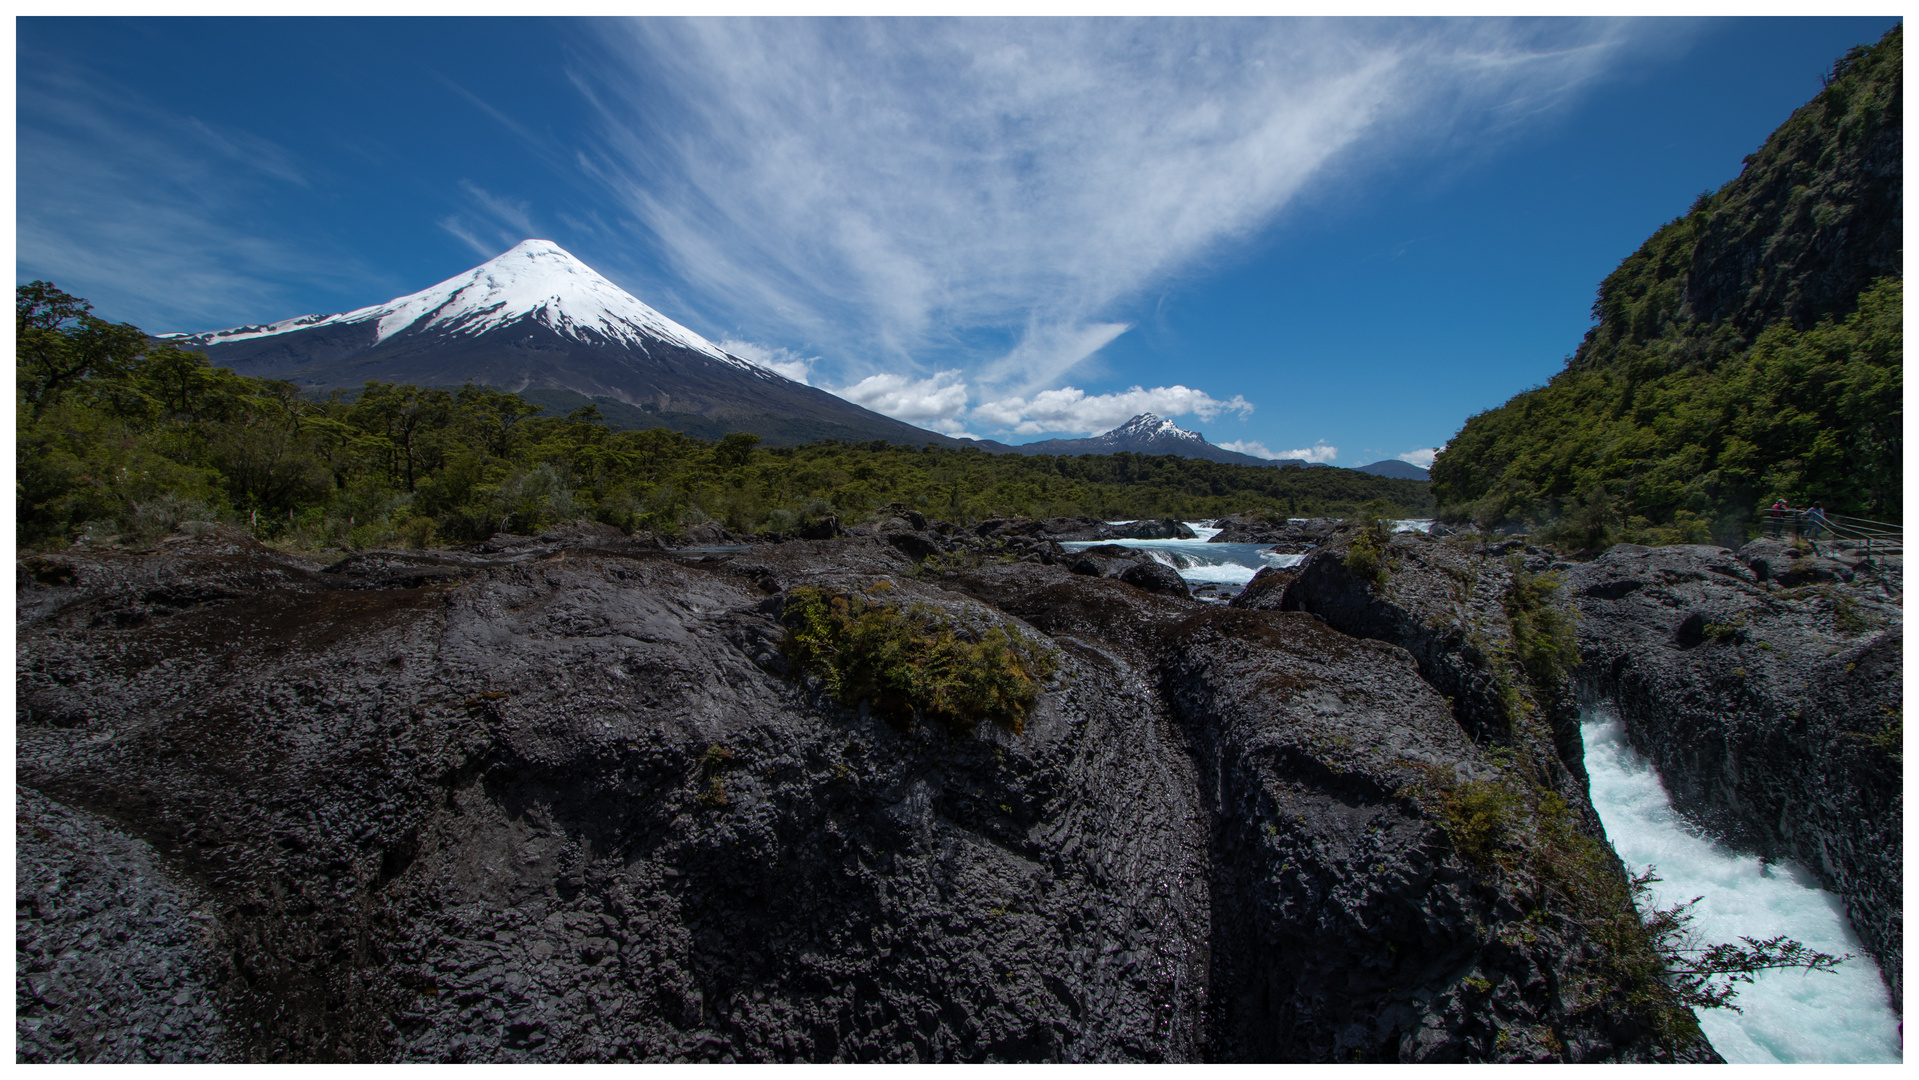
top-left (576, 19), bottom-right (1629, 432)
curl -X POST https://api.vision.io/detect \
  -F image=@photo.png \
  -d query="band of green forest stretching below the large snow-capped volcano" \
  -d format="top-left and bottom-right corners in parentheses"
top-left (15, 282), bottom-right (1432, 549)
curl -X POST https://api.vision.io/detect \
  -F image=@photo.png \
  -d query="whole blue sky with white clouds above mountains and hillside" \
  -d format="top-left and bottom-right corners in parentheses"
top-left (15, 17), bottom-right (1896, 466)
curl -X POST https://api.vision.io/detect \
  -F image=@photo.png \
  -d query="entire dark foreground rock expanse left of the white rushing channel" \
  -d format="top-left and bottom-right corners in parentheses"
top-left (17, 518), bottom-right (1716, 1061)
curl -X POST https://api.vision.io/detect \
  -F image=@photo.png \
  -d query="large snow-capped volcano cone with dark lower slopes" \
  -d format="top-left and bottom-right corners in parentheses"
top-left (173, 240), bottom-right (960, 445)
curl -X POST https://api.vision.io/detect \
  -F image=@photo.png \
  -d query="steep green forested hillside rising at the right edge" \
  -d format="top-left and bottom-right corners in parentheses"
top-left (1432, 27), bottom-right (1904, 547)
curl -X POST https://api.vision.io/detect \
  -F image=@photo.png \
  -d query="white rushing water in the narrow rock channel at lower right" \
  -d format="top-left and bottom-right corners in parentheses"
top-left (1579, 706), bottom-right (1902, 1065)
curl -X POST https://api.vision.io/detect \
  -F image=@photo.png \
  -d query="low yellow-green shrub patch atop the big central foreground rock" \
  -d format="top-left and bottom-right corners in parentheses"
top-left (781, 583), bottom-right (1059, 733)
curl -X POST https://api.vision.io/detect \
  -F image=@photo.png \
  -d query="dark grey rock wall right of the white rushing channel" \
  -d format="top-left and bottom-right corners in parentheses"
top-left (1566, 541), bottom-right (1904, 1003)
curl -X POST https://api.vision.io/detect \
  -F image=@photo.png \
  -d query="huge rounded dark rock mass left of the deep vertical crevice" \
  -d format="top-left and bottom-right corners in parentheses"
top-left (21, 541), bottom-right (1205, 1061)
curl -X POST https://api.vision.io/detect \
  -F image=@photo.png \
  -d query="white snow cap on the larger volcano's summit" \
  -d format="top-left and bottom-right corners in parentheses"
top-left (176, 240), bottom-right (771, 374)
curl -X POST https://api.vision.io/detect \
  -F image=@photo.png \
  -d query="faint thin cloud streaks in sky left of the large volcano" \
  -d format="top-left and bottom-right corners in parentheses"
top-left (15, 56), bottom-right (384, 332)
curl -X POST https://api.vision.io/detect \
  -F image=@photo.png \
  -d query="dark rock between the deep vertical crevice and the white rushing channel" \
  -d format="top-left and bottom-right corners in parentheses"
top-left (1165, 608), bottom-right (1716, 1061)
